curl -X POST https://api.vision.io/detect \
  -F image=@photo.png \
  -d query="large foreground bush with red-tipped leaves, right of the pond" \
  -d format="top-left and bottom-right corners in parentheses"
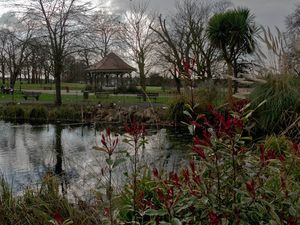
top-left (120, 108), bottom-right (300, 225)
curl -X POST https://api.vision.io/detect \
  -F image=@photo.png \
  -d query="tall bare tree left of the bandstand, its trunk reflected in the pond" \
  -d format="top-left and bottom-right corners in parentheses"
top-left (21, 0), bottom-right (90, 106)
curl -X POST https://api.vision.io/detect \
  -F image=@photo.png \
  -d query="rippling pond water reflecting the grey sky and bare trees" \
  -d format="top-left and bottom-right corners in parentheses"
top-left (0, 121), bottom-right (191, 194)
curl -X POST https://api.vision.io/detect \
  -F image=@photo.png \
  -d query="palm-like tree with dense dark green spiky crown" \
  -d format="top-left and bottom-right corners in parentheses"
top-left (208, 8), bottom-right (259, 97)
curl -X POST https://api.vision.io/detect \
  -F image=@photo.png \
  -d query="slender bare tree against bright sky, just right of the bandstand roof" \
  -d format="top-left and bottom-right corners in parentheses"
top-left (122, 3), bottom-right (156, 91)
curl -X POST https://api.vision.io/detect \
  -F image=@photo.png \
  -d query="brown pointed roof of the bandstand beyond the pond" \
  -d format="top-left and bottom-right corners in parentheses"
top-left (87, 52), bottom-right (136, 73)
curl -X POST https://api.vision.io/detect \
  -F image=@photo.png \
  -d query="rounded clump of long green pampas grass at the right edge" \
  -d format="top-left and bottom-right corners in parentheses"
top-left (250, 75), bottom-right (300, 135)
